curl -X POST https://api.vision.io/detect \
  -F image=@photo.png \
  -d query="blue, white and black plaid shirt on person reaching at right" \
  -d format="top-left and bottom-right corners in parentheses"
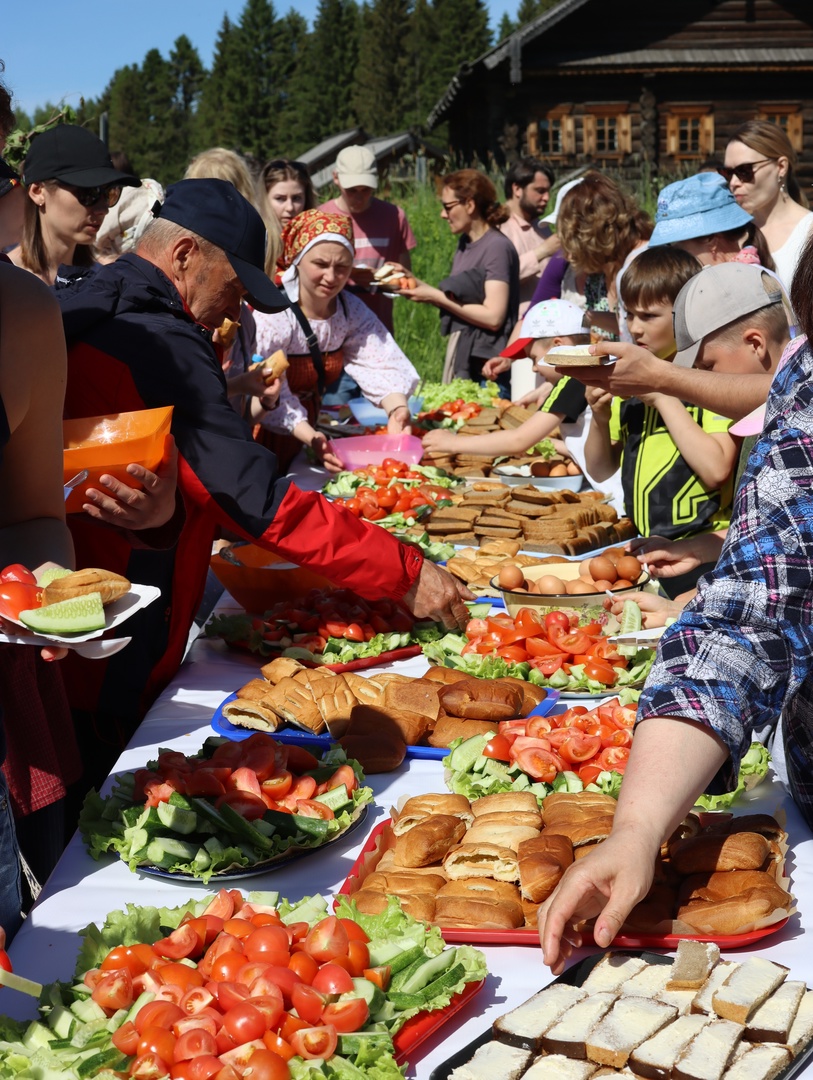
top-left (638, 338), bottom-right (813, 827)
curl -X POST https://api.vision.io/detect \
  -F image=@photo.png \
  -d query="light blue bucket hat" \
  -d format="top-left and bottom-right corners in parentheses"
top-left (649, 173), bottom-right (754, 247)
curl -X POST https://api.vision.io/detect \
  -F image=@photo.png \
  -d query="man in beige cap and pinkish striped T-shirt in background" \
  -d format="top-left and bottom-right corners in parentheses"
top-left (322, 146), bottom-right (417, 334)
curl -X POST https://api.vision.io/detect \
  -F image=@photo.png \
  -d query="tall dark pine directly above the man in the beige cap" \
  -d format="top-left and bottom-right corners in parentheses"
top-left (353, 0), bottom-right (412, 135)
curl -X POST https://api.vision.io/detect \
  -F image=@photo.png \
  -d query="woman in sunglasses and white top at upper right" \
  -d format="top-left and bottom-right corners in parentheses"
top-left (719, 120), bottom-right (813, 291)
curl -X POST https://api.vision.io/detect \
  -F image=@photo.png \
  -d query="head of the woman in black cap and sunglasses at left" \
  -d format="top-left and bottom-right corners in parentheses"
top-left (11, 124), bottom-right (141, 285)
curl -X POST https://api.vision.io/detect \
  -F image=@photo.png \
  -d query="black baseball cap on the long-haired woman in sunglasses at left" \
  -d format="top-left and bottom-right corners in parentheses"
top-left (23, 124), bottom-right (141, 188)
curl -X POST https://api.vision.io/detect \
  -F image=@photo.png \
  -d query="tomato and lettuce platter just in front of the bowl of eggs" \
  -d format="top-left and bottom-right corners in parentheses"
top-left (423, 608), bottom-right (655, 698)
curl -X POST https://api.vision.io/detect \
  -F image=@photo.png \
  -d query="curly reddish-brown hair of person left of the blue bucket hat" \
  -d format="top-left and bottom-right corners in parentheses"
top-left (556, 172), bottom-right (654, 273)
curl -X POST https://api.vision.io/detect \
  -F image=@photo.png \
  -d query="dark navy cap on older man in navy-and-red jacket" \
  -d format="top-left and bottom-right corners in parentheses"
top-left (152, 178), bottom-right (290, 313)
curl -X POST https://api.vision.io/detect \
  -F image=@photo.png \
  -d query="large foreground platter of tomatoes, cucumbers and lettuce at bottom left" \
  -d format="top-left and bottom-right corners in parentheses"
top-left (0, 889), bottom-right (486, 1080)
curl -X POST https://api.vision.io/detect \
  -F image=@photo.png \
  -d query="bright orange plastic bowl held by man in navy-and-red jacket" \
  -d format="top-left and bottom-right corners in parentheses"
top-left (63, 405), bottom-right (172, 514)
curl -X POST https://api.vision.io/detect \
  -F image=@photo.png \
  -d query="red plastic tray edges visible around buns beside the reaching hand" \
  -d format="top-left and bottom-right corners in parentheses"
top-left (339, 818), bottom-right (787, 949)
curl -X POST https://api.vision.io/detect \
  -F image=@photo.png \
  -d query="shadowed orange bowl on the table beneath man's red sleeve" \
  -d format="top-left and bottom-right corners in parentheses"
top-left (211, 544), bottom-right (335, 615)
